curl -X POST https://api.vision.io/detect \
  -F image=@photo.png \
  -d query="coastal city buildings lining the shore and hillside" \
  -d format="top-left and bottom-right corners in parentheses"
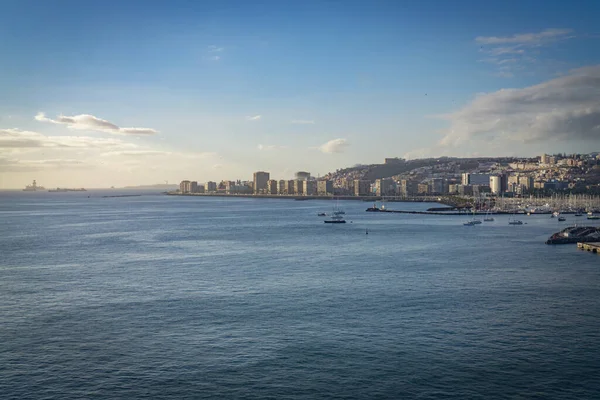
top-left (179, 153), bottom-right (600, 197)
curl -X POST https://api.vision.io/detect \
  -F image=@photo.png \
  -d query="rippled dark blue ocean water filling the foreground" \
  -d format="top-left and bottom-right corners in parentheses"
top-left (0, 191), bottom-right (600, 399)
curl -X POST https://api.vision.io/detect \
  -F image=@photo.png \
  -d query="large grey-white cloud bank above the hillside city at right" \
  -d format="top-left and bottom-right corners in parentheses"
top-left (440, 65), bottom-right (600, 146)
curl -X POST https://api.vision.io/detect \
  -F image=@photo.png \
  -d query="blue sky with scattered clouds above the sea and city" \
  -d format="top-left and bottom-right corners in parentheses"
top-left (0, 0), bottom-right (600, 188)
